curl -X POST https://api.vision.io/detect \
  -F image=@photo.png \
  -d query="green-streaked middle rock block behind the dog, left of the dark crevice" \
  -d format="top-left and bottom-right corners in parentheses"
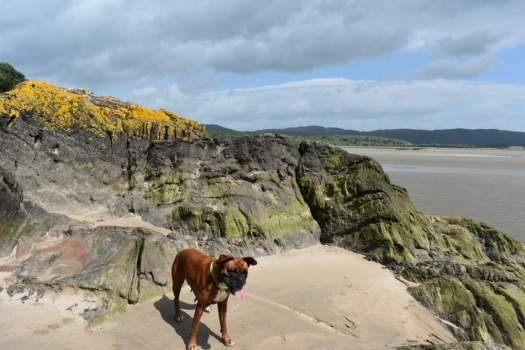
top-left (139, 137), bottom-right (319, 247)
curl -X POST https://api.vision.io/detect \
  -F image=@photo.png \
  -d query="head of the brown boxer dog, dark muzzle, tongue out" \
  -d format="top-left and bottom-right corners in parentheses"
top-left (217, 254), bottom-right (257, 294)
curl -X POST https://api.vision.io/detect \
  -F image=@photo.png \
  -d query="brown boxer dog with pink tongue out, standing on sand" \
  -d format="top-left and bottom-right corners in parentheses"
top-left (171, 249), bottom-right (257, 350)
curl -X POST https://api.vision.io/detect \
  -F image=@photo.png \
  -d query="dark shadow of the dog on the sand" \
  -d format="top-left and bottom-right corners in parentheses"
top-left (153, 295), bottom-right (222, 349)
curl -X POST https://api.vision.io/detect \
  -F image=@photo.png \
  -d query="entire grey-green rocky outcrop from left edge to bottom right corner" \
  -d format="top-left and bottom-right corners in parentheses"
top-left (0, 85), bottom-right (525, 349)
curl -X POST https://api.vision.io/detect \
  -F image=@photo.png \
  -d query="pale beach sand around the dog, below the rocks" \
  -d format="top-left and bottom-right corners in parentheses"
top-left (0, 245), bottom-right (455, 350)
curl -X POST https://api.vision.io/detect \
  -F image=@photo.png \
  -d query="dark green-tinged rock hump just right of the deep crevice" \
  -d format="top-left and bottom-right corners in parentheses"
top-left (298, 142), bottom-right (435, 264)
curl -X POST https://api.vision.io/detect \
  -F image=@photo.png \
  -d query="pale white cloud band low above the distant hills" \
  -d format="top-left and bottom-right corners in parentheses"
top-left (133, 79), bottom-right (525, 131)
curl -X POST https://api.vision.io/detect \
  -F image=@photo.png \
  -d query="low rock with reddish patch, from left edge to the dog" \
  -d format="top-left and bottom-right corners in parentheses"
top-left (0, 164), bottom-right (177, 321)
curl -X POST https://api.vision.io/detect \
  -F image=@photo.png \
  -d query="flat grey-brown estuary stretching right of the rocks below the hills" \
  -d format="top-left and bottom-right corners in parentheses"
top-left (343, 147), bottom-right (525, 242)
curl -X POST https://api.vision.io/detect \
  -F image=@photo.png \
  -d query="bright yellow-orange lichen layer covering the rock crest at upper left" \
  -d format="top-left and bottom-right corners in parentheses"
top-left (0, 81), bottom-right (206, 141)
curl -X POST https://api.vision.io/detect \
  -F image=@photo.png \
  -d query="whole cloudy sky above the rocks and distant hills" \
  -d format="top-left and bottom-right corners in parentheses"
top-left (0, 0), bottom-right (525, 131)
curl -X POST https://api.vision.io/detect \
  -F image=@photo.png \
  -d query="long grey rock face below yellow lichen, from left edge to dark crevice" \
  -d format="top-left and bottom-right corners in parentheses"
top-left (0, 95), bottom-right (319, 254)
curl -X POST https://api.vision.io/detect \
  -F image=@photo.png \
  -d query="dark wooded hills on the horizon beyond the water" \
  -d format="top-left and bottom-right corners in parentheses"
top-left (253, 126), bottom-right (525, 147)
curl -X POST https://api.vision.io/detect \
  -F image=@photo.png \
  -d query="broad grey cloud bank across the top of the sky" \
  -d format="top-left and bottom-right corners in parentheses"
top-left (0, 0), bottom-right (525, 88)
